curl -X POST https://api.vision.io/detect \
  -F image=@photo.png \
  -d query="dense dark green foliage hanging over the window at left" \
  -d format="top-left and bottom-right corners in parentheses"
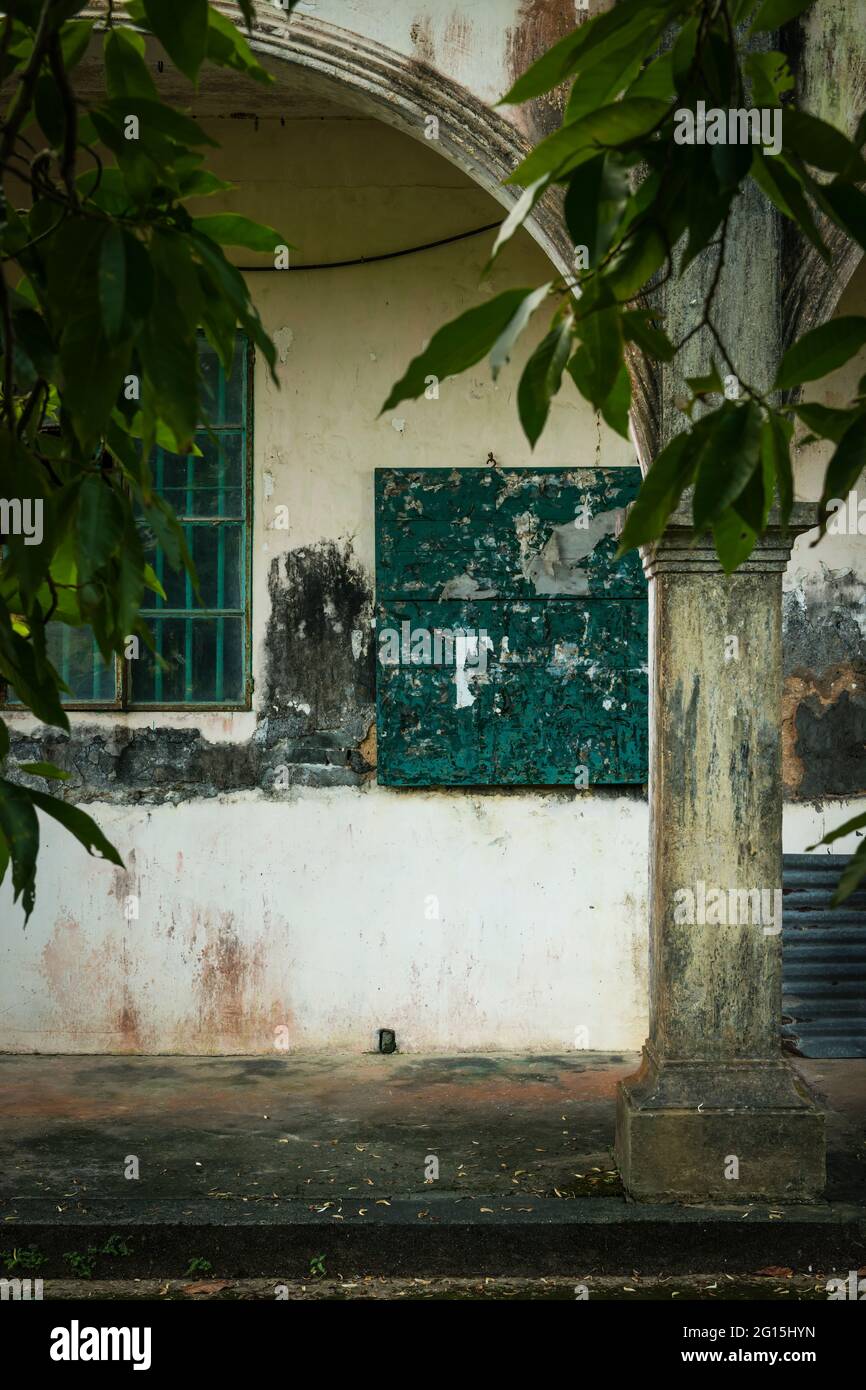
top-left (0, 0), bottom-right (294, 916)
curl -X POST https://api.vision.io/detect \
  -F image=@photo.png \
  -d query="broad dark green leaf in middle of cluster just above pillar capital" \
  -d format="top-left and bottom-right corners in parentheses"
top-left (692, 400), bottom-right (762, 537)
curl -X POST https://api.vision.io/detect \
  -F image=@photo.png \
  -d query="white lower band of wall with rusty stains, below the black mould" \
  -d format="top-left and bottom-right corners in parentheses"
top-left (0, 788), bottom-right (646, 1054)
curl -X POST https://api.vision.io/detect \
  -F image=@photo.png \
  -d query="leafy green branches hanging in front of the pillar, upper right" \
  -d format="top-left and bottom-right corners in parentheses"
top-left (382, 0), bottom-right (866, 899)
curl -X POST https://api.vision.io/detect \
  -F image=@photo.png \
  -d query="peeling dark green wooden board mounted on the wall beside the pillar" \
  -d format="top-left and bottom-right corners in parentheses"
top-left (375, 468), bottom-right (646, 787)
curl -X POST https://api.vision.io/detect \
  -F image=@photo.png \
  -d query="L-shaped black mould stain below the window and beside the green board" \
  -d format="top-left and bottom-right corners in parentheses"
top-left (4, 541), bottom-right (375, 803)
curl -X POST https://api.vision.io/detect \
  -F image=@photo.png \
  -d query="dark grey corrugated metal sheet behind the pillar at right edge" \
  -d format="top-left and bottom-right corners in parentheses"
top-left (781, 855), bottom-right (866, 1056)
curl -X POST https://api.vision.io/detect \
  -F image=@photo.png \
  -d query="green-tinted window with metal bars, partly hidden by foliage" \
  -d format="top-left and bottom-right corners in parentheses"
top-left (7, 334), bottom-right (252, 709)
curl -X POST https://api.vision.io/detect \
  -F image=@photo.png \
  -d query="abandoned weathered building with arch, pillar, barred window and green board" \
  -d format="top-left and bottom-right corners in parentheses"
top-left (0, 0), bottom-right (866, 1197)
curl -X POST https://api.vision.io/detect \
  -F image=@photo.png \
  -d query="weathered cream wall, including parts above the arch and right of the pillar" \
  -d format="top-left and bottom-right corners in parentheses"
top-left (0, 13), bottom-right (866, 1052)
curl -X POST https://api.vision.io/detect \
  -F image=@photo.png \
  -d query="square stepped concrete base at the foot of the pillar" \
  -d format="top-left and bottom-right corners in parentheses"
top-left (616, 1045), bottom-right (826, 1205)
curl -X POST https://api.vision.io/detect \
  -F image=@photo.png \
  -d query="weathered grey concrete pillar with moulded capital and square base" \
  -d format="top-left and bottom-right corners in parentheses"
top-left (616, 506), bottom-right (824, 1202)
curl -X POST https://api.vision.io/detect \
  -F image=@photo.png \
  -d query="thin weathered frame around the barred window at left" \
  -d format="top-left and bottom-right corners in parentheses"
top-left (0, 332), bottom-right (256, 714)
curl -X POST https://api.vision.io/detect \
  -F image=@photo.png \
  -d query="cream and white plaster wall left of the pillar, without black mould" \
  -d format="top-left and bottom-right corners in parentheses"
top-left (0, 108), bottom-right (646, 1054)
